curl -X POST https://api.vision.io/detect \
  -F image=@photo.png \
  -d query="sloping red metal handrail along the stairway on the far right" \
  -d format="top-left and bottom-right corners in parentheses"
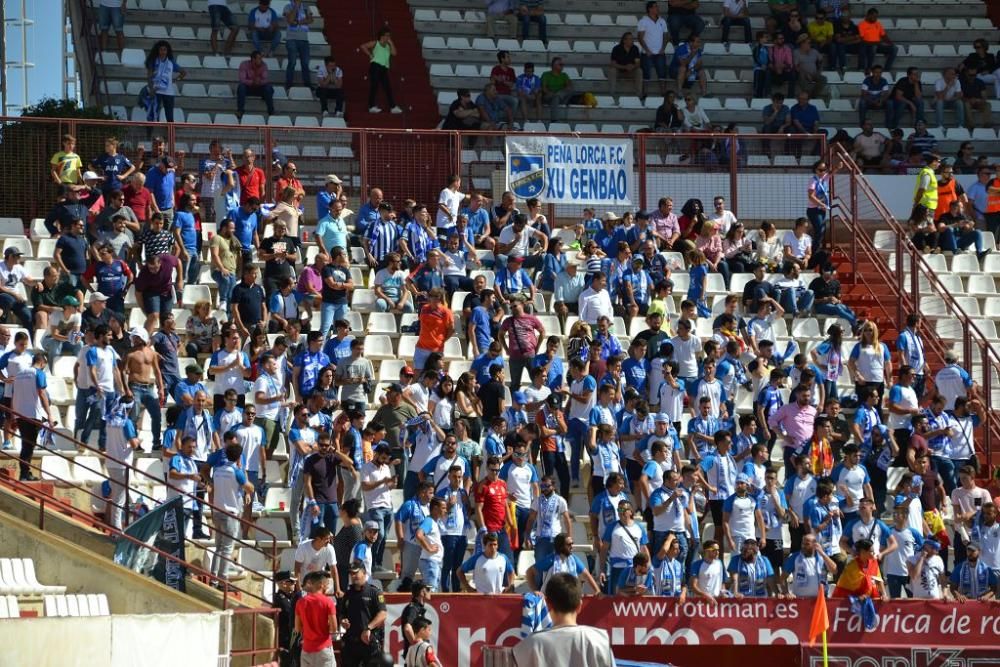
top-left (830, 145), bottom-right (1000, 467)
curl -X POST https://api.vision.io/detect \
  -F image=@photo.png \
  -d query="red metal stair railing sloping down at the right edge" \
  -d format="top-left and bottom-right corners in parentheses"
top-left (829, 145), bottom-right (1000, 477)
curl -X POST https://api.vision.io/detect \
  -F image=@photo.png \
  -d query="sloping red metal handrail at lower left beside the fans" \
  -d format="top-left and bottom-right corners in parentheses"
top-left (0, 405), bottom-right (278, 579)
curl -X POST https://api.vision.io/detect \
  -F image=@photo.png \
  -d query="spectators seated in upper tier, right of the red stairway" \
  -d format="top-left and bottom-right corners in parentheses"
top-left (454, 0), bottom-right (1000, 166)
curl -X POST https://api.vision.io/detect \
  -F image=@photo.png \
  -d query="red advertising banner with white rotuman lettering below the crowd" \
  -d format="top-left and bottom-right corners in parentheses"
top-left (387, 595), bottom-right (1000, 667)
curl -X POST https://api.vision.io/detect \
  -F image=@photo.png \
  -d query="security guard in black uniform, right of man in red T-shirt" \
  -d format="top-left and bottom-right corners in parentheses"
top-left (337, 560), bottom-right (391, 667)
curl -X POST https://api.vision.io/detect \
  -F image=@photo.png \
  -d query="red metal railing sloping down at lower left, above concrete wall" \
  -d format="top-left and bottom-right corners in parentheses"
top-left (0, 406), bottom-right (278, 603)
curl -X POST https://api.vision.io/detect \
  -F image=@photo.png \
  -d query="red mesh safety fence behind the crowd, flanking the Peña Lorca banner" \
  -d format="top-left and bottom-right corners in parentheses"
top-left (0, 118), bottom-right (826, 221)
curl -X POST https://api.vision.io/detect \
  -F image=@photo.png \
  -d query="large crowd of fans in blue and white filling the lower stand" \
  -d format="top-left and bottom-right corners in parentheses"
top-left (21, 126), bottom-right (1000, 632)
